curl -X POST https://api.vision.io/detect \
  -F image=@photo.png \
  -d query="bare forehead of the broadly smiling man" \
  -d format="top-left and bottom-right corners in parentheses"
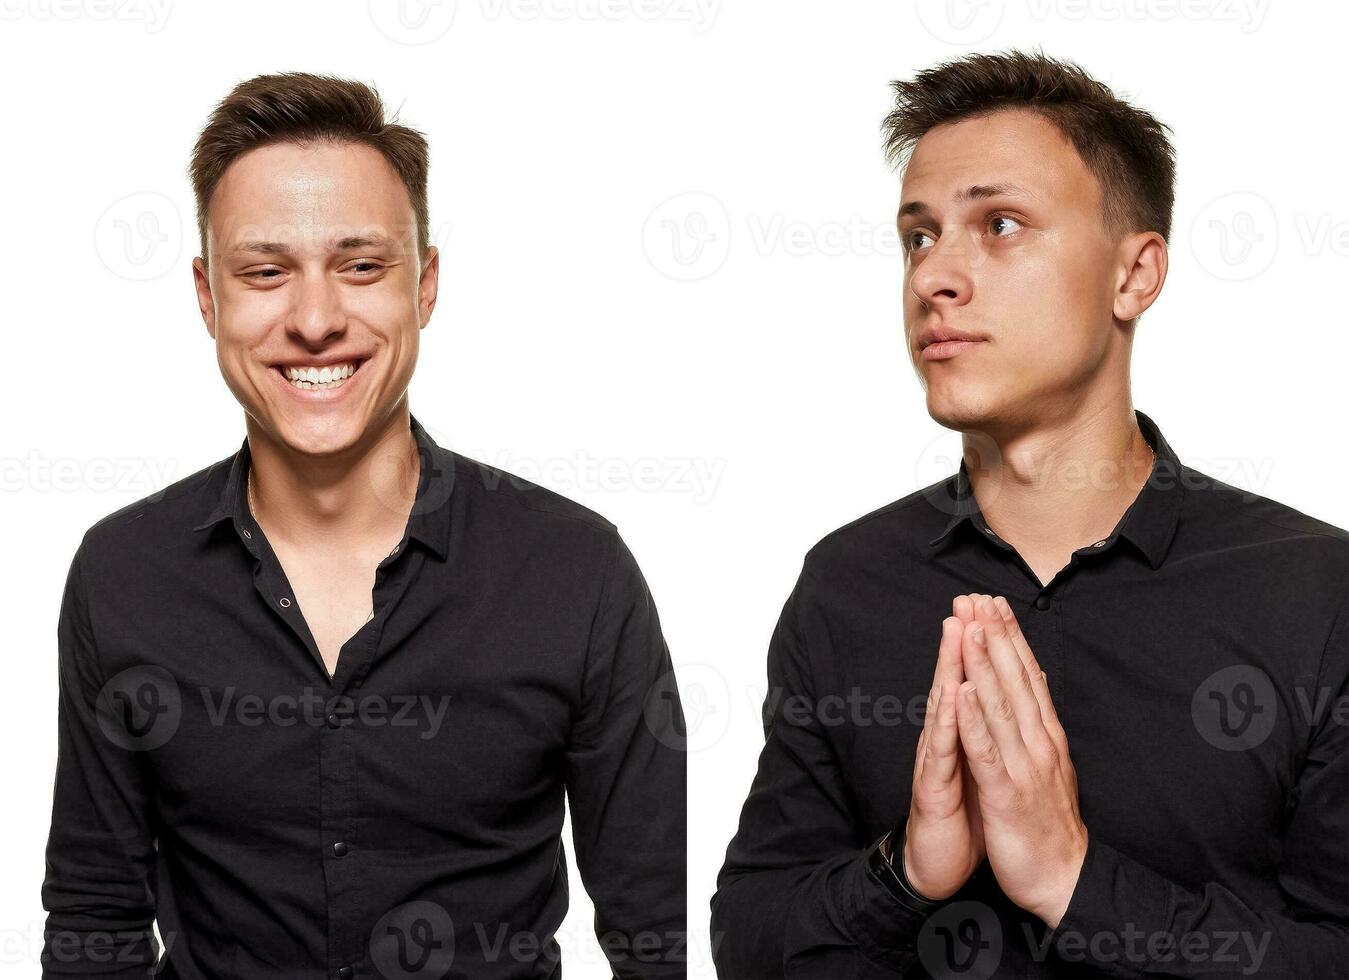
top-left (208, 142), bottom-right (415, 246)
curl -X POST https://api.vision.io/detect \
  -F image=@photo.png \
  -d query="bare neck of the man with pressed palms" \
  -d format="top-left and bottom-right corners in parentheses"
top-left (963, 401), bottom-right (1153, 562)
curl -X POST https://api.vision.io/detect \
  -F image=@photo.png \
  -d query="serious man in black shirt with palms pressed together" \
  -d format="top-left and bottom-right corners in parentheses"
top-left (712, 51), bottom-right (1349, 979)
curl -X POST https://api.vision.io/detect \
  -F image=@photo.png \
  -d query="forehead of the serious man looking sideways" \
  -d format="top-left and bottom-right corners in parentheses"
top-left (902, 109), bottom-right (1098, 214)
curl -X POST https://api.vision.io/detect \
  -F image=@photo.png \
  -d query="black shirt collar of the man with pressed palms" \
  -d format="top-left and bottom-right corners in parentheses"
top-left (928, 409), bottom-right (1184, 568)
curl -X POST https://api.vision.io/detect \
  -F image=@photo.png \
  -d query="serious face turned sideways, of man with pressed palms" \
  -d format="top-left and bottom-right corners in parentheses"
top-left (898, 109), bottom-right (1133, 431)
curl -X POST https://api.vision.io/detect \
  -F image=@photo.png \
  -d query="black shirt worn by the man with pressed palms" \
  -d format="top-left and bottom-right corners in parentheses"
top-left (712, 412), bottom-right (1349, 980)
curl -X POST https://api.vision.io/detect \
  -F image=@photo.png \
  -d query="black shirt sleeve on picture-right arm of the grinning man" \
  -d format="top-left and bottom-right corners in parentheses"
top-left (567, 535), bottom-right (688, 980)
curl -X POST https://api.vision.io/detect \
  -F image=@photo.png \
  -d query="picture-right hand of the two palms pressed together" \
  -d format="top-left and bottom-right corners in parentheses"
top-left (956, 597), bottom-right (1087, 929)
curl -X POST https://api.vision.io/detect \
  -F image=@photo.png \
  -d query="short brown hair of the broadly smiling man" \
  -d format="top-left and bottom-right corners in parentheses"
top-left (188, 72), bottom-right (430, 263)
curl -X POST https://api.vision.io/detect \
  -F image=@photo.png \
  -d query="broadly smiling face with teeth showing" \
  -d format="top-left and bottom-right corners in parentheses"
top-left (193, 142), bottom-right (438, 455)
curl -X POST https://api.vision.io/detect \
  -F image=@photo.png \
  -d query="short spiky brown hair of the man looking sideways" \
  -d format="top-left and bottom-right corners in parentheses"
top-left (881, 50), bottom-right (1175, 247)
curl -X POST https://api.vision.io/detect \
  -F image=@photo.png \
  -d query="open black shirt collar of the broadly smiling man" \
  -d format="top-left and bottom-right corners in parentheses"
top-left (193, 413), bottom-right (455, 559)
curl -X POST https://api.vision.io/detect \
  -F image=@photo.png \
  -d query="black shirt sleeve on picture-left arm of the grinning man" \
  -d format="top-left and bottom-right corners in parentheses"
top-left (42, 544), bottom-right (159, 977)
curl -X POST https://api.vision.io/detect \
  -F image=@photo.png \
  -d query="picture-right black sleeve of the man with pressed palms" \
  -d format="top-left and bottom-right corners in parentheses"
top-left (1047, 591), bottom-right (1349, 980)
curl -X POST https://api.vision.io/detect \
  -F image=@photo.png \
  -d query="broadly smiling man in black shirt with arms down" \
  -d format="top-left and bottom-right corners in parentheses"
top-left (42, 73), bottom-right (685, 980)
